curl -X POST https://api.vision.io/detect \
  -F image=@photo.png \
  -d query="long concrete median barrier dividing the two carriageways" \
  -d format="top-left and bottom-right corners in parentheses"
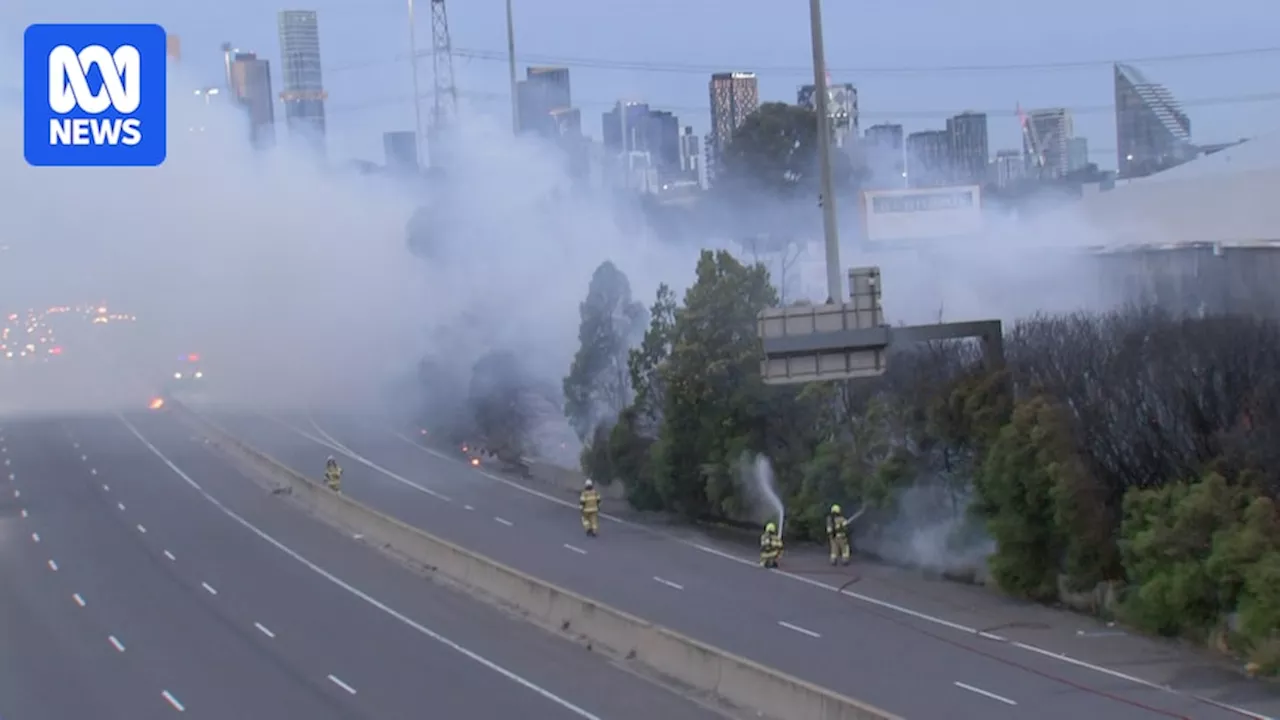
top-left (169, 404), bottom-right (900, 720)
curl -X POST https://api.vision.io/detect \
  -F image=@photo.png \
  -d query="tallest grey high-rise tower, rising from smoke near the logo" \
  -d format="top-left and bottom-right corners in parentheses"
top-left (279, 10), bottom-right (328, 146)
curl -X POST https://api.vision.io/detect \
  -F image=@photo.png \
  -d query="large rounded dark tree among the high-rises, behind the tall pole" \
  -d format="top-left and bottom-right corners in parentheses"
top-left (717, 102), bottom-right (852, 197)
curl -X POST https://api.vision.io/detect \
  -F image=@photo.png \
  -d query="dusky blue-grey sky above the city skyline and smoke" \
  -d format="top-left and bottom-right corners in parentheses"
top-left (0, 0), bottom-right (1280, 168)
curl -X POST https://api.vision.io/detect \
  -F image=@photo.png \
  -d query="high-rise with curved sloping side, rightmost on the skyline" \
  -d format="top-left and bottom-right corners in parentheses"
top-left (1115, 63), bottom-right (1196, 178)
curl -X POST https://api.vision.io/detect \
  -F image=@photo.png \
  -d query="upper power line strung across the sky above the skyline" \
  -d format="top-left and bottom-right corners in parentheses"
top-left (328, 46), bottom-right (1280, 76)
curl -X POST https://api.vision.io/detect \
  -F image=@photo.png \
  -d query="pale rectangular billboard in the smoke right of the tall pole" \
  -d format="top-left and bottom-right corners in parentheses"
top-left (861, 184), bottom-right (982, 242)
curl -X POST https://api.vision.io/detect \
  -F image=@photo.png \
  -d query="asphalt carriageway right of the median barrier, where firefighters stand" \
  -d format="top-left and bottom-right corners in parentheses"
top-left (207, 415), bottom-right (1269, 720)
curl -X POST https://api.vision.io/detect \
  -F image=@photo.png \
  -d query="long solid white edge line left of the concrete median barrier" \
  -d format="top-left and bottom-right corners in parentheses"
top-left (116, 414), bottom-right (603, 720)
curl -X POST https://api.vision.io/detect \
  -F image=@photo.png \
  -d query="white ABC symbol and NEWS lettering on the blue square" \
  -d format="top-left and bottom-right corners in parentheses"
top-left (49, 45), bottom-right (142, 146)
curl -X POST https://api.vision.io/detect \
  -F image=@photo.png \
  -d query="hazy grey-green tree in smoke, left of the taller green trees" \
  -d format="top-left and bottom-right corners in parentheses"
top-left (563, 261), bottom-right (645, 442)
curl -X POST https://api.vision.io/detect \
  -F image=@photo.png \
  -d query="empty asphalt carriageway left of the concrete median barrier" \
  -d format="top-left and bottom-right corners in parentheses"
top-left (0, 414), bottom-right (718, 720)
